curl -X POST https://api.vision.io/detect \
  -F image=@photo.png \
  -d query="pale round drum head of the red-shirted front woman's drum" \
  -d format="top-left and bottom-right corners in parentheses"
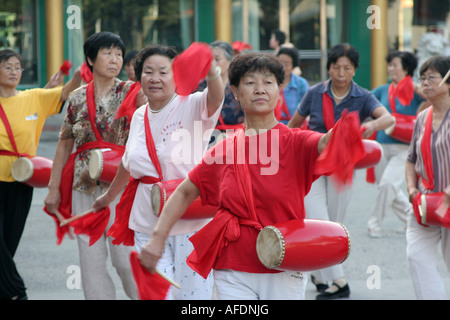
top-left (256, 226), bottom-right (285, 269)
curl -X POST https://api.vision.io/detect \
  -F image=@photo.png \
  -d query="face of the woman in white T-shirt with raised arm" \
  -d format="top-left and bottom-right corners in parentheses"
top-left (141, 55), bottom-right (175, 101)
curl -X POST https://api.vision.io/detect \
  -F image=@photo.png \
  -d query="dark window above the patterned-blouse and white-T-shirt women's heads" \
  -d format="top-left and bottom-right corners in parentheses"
top-left (82, 0), bottom-right (195, 52)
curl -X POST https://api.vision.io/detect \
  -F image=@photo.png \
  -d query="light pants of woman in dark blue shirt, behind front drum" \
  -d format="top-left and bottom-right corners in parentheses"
top-left (305, 176), bottom-right (353, 282)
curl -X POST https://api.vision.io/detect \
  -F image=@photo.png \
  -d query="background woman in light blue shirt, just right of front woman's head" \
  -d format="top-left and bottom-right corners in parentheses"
top-left (277, 48), bottom-right (309, 124)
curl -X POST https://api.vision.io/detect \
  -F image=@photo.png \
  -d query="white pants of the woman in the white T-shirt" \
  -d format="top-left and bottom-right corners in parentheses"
top-left (135, 232), bottom-right (214, 300)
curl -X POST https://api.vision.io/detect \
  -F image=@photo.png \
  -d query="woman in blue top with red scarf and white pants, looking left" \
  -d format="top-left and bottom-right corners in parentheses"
top-left (367, 51), bottom-right (423, 238)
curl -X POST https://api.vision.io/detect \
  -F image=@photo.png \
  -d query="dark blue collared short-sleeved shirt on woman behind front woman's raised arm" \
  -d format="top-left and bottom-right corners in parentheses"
top-left (298, 80), bottom-right (382, 133)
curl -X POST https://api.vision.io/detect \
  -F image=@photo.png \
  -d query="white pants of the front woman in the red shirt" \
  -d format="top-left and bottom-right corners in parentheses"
top-left (214, 269), bottom-right (307, 300)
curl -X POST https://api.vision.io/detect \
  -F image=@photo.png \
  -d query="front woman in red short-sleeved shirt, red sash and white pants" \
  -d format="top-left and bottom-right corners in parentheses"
top-left (140, 53), bottom-right (336, 300)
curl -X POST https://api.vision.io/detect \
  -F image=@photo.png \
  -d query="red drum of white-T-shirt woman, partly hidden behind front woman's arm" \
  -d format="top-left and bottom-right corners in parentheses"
top-left (152, 179), bottom-right (217, 219)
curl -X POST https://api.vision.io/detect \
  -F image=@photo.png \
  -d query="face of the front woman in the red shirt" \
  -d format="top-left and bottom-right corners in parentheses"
top-left (232, 71), bottom-right (280, 116)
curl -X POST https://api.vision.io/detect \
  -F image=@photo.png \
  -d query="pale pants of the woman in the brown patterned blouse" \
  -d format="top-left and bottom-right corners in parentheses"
top-left (72, 187), bottom-right (137, 300)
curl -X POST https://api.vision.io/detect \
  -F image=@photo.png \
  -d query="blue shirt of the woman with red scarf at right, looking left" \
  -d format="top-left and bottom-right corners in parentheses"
top-left (373, 84), bottom-right (424, 143)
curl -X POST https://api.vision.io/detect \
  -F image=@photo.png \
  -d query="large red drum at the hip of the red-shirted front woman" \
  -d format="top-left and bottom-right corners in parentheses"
top-left (256, 219), bottom-right (350, 271)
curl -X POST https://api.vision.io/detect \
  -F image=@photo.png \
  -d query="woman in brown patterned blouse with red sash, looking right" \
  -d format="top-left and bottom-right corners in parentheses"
top-left (45, 32), bottom-right (144, 299)
